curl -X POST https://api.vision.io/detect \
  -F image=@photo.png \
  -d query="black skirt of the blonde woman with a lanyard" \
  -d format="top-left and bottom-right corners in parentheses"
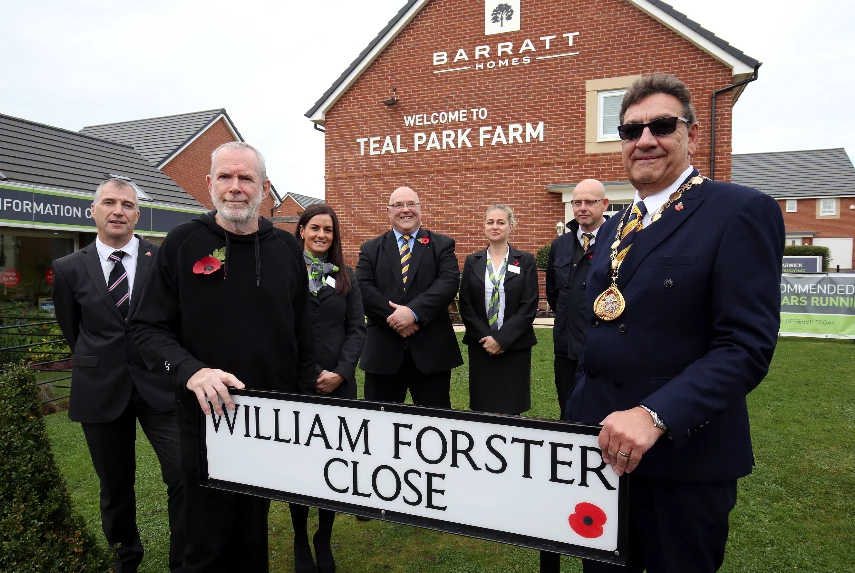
top-left (468, 344), bottom-right (531, 415)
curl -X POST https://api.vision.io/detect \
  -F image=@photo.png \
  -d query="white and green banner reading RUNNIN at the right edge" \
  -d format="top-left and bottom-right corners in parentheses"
top-left (781, 273), bottom-right (855, 338)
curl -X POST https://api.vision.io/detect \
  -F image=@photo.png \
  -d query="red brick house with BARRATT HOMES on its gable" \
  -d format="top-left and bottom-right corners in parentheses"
top-left (306, 0), bottom-right (760, 263)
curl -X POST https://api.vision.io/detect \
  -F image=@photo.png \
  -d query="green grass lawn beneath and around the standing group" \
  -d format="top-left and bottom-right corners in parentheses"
top-left (47, 329), bottom-right (855, 573)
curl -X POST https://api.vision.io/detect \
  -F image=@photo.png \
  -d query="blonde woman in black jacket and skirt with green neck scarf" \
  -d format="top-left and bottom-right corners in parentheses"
top-left (460, 205), bottom-right (539, 415)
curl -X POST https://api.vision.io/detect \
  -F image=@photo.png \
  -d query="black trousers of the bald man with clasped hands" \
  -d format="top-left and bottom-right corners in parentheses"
top-left (365, 348), bottom-right (451, 408)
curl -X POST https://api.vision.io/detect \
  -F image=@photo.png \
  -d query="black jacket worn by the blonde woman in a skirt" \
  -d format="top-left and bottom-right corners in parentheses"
top-left (460, 246), bottom-right (539, 350)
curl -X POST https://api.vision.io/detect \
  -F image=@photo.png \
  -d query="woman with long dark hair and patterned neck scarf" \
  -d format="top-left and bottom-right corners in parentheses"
top-left (290, 204), bottom-right (365, 573)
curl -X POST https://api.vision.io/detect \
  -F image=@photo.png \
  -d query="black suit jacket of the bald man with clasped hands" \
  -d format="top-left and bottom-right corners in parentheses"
top-left (356, 228), bottom-right (463, 374)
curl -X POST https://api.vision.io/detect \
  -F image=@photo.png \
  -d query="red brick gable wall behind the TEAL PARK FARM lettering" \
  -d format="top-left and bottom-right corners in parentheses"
top-left (325, 0), bottom-right (732, 264)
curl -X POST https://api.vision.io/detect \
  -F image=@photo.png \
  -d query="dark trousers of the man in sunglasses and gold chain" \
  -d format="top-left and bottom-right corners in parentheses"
top-left (582, 475), bottom-right (736, 573)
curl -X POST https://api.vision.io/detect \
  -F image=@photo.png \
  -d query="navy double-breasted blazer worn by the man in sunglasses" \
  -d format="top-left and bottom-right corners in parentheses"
top-left (567, 172), bottom-right (784, 481)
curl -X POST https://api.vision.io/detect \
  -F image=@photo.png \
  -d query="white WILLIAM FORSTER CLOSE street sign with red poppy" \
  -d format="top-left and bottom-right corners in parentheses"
top-left (200, 390), bottom-right (627, 564)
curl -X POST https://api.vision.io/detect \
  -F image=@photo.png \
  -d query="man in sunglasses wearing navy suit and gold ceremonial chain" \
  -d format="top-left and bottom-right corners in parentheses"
top-left (567, 74), bottom-right (784, 573)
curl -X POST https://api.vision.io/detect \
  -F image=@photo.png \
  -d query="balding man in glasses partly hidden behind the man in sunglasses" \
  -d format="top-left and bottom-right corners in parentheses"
top-left (546, 179), bottom-right (609, 418)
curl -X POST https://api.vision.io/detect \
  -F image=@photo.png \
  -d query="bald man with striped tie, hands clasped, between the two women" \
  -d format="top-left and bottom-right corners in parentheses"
top-left (356, 187), bottom-right (463, 408)
